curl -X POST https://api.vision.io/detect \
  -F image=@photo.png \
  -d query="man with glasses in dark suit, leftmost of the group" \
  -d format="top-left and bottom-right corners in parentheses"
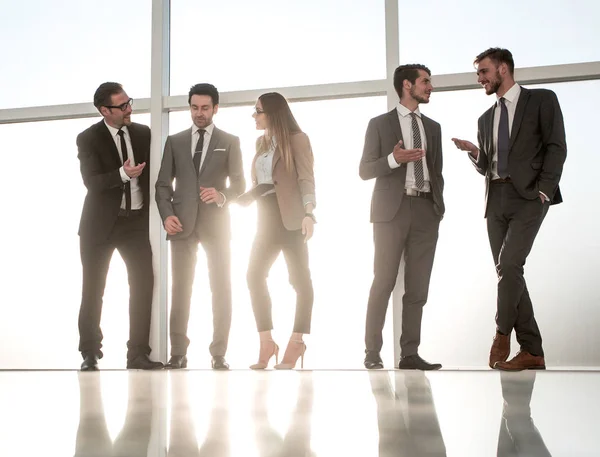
top-left (77, 82), bottom-right (163, 371)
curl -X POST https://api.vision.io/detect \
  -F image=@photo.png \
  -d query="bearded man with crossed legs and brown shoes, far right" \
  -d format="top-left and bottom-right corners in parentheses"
top-left (452, 48), bottom-right (567, 370)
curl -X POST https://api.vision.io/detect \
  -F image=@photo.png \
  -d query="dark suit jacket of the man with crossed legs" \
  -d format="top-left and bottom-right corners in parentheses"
top-left (471, 87), bottom-right (567, 214)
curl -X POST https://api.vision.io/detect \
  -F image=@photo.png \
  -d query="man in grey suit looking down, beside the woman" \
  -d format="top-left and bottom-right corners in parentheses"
top-left (156, 84), bottom-right (246, 370)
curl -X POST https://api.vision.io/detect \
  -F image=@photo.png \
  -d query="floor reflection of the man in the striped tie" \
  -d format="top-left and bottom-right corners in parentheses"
top-left (369, 371), bottom-right (446, 457)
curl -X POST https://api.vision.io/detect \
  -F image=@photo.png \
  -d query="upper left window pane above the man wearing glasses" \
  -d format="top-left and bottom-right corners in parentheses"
top-left (0, 0), bottom-right (151, 108)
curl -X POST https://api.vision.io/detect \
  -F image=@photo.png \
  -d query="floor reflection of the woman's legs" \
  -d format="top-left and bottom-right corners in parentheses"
top-left (252, 372), bottom-right (317, 457)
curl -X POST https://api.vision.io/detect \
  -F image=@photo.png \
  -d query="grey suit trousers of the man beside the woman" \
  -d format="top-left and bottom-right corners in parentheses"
top-left (170, 217), bottom-right (232, 357)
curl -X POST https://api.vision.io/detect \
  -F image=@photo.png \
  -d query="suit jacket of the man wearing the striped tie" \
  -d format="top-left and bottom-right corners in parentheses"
top-left (359, 108), bottom-right (445, 222)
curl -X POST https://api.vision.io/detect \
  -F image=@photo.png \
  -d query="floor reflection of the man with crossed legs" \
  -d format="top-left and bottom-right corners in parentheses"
top-left (498, 371), bottom-right (551, 457)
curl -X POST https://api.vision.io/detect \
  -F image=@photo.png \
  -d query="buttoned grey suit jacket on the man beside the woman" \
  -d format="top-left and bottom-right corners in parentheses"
top-left (156, 127), bottom-right (246, 240)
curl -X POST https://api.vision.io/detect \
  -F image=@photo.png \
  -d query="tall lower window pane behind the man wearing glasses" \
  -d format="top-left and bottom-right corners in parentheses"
top-left (0, 115), bottom-right (150, 369)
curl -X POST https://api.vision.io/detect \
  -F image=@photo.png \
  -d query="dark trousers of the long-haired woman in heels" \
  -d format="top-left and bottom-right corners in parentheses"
top-left (247, 193), bottom-right (314, 334)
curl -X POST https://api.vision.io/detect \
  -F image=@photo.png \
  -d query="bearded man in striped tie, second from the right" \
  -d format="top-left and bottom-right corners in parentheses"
top-left (359, 64), bottom-right (444, 370)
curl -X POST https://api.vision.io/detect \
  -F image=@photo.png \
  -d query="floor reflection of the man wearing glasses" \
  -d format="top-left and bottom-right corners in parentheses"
top-left (75, 371), bottom-right (155, 457)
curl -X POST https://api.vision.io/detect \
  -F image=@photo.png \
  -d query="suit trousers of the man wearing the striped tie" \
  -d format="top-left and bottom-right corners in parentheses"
top-left (365, 195), bottom-right (440, 357)
